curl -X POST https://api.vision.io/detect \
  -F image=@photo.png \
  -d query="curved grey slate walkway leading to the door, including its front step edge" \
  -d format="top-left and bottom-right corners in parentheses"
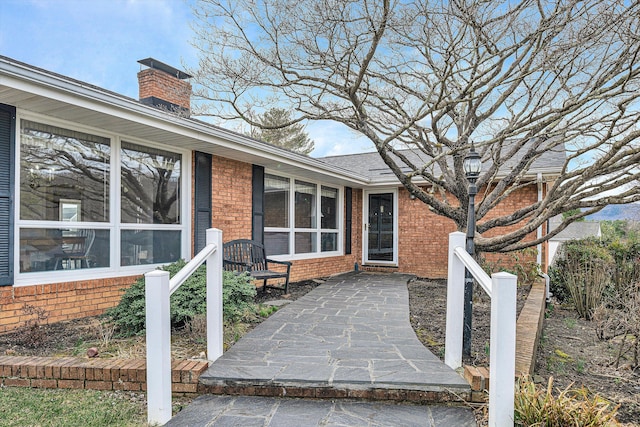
top-left (200, 272), bottom-right (471, 403)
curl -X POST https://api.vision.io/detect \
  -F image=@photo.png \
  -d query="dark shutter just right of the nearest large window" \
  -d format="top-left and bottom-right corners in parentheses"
top-left (193, 151), bottom-right (211, 254)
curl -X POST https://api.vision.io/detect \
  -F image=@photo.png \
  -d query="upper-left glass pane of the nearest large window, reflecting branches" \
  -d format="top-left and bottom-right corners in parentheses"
top-left (20, 120), bottom-right (111, 222)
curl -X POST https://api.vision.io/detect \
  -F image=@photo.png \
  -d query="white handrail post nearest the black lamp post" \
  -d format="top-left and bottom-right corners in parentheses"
top-left (444, 231), bottom-right (466, 369)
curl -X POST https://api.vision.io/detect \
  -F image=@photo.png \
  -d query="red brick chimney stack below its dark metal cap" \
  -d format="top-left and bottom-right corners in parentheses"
top-left (138, 68), bottom-right (191, 110)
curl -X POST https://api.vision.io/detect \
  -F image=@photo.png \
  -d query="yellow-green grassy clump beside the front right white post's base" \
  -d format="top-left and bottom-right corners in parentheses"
top-left (514, 377), bottom-right (619, 427)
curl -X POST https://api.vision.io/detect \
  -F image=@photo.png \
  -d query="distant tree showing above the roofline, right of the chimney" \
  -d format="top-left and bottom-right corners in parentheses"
top-left (249, 107), bottom-right (315, 154)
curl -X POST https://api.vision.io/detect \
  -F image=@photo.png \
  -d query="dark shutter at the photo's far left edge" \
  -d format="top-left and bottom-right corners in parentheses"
top-left (0, 104), bottom-right (16, 286)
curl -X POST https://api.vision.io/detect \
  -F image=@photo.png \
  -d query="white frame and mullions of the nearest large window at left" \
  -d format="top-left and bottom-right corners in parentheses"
top-left (13, 111), bottom-right (191, 286)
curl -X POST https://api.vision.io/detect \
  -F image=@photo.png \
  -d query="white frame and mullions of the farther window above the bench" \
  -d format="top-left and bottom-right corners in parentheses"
top-left (264, 170), bottom-right (345, 261)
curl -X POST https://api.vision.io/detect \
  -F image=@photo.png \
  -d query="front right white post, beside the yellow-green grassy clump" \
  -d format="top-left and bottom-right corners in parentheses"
top-left (489, 272), bottom-right (518, 427)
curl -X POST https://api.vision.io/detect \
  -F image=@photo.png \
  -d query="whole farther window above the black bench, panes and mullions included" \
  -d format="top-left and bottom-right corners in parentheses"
top-left (264, 174), bottom-right (340, 256)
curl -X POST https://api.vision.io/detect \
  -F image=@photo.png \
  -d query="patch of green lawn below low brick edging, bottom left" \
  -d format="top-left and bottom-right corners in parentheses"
top-left (0, 387), bottom-right (147, 427)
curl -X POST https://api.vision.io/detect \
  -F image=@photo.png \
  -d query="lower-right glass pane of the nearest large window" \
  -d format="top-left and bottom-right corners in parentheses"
top-left (120, 230), bottom-right (181, 266)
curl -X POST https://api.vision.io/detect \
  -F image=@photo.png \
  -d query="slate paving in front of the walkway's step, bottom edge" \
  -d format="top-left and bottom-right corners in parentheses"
top-left (165, 396), bottom-right (476, 427)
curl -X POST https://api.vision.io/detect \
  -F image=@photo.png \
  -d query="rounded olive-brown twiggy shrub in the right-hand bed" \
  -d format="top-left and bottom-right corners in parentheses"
top-left (549, 239), bottom-right (614, 320)
